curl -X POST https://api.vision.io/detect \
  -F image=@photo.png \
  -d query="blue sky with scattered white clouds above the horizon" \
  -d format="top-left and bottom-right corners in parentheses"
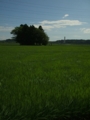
top-left (0, 0), bottom-right (90, 41)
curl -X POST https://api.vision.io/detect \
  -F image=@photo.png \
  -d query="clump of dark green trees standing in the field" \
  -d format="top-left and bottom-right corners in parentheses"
top-left (11, 24), bottom-right (49, 45)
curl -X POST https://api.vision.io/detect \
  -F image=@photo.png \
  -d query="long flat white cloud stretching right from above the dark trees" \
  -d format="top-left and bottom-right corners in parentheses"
top-left (34, 20), bottom-right (85, 30)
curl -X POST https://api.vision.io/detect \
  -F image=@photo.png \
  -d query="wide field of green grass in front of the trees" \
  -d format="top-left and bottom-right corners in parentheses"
top-left (0, 45), bottom-right (90, 120)
